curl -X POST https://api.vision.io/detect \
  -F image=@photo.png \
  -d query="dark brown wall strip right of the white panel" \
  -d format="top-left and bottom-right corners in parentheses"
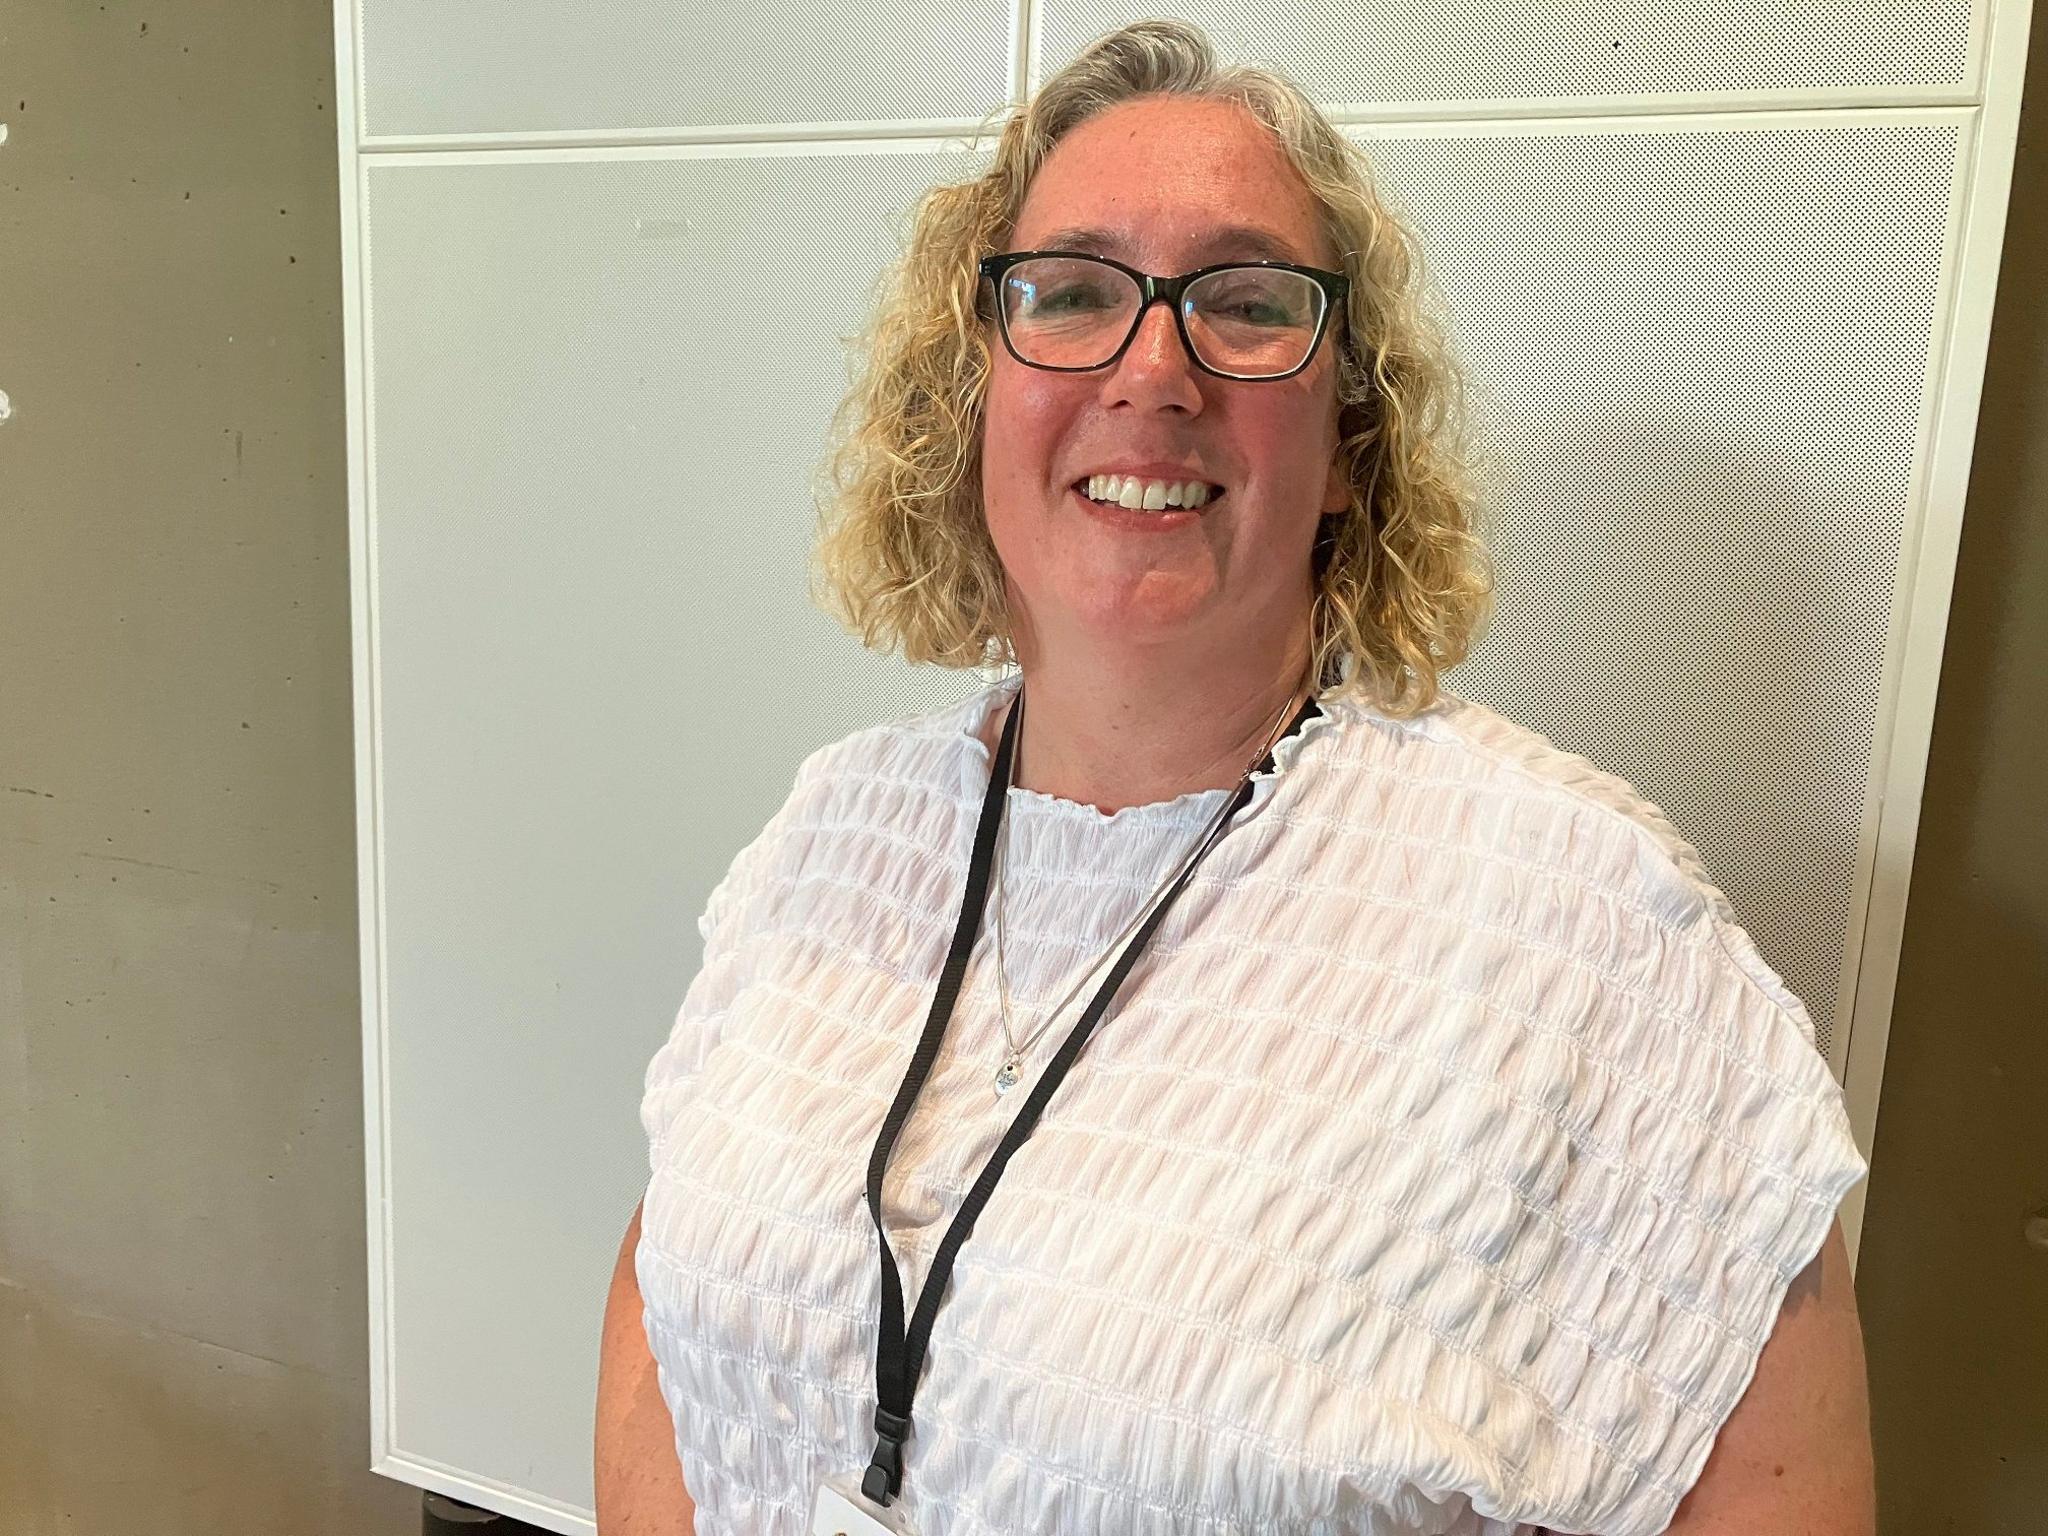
top-left (1855, 6), bottom-right (2048, 1536)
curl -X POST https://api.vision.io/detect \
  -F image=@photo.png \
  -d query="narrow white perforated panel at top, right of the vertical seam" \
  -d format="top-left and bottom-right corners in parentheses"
top-left (1034, 0), bottom-right (1976, 111)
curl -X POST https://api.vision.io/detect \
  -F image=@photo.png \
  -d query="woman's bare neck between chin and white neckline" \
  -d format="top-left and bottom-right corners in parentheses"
top-left (983, 633), bottom-right (1309, 811)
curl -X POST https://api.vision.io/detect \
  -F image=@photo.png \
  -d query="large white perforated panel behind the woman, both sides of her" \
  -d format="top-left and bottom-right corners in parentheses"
top-left (348, 123), bottom-right (1956, 1499)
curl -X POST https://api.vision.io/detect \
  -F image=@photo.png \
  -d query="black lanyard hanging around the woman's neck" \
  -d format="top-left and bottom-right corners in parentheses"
top-left (860, 686), bottom-right (1317, 1507)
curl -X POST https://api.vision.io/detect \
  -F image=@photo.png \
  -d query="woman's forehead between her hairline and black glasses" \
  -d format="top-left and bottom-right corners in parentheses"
top-left (1012, 96), bottom-right (1335, 270)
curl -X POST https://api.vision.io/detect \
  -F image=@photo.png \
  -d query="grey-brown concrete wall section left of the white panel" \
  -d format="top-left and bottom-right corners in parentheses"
top-left (0, 0), bottom-right (415, 1536)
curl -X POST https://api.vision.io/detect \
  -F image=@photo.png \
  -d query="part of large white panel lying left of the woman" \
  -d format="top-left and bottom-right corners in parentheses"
top-left (365, 154), bottom-right (995, 1526)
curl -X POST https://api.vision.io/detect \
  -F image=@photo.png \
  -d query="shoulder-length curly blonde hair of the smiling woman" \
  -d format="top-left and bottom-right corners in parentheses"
top-left (813, 20), bottom-right (1493, 717)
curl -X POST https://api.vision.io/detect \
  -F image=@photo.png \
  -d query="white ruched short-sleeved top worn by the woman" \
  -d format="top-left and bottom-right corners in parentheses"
top-left (637, 678), bottom-right (1866, 1536)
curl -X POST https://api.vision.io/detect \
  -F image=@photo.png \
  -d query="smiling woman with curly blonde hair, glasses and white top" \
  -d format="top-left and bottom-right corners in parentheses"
top-left (598, 23), bottom-right (1872, 1536)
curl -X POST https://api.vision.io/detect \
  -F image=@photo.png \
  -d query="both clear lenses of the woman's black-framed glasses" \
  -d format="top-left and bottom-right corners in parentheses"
top-left (1001, 256), bottom-right (1325, 377)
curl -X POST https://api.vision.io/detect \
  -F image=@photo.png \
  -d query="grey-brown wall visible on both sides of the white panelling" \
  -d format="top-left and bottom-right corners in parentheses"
top-left (0, 0), bottom-right (2048, 1536)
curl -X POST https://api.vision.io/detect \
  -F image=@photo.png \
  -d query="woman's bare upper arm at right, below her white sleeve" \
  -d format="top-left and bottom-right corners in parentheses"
top-left (1667, 1223), bottom-right (1878, 1536)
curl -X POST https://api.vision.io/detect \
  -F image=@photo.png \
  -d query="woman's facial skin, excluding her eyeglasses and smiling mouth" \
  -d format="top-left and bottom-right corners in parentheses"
top-left (981, 96), bottom-right (1350, 662)
